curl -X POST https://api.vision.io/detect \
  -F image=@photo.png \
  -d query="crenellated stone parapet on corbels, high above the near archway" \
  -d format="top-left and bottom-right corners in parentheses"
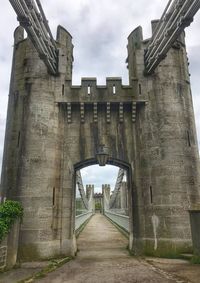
top-left (56, 77), bottom-right (147, 123)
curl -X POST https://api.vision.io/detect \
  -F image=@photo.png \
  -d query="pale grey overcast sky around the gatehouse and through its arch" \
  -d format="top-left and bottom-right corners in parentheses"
top-left (0, 0), bottom-right (200, 193)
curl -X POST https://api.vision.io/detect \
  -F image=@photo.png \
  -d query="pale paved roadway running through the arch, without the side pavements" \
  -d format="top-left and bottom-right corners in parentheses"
top-left (39, 214), bottom-right (184, 283)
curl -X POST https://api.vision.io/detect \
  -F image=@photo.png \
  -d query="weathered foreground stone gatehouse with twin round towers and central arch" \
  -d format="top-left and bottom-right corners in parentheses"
top-left (2, 18), bottom-right (200, 259)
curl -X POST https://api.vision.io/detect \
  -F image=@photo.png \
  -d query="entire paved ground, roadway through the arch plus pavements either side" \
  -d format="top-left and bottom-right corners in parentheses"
top-left (0, 214), bottom-right (200, 283)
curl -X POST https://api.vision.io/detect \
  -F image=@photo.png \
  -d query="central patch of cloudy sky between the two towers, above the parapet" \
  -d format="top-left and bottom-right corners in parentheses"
top-left (41, 0), bottom-right (172, 85)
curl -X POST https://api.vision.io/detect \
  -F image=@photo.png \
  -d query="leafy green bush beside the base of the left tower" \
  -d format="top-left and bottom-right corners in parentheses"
top-left (0, 200), bottom-right (23, 241)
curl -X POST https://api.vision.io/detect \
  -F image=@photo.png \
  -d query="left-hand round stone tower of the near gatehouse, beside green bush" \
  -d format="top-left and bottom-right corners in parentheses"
top-left (2, 27), bottom-right (74, 259)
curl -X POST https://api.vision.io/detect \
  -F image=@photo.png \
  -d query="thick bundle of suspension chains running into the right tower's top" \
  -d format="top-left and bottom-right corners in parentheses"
top-left (144, 0), bottom-right (200, 74)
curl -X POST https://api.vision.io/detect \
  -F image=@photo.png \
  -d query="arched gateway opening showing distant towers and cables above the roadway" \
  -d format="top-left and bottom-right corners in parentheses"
top-left (74, 158), bottom-right (133, 254)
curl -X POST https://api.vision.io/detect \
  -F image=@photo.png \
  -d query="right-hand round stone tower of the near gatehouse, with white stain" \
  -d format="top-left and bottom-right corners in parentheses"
top-left (128, 23), bottom-right (200, 255)
